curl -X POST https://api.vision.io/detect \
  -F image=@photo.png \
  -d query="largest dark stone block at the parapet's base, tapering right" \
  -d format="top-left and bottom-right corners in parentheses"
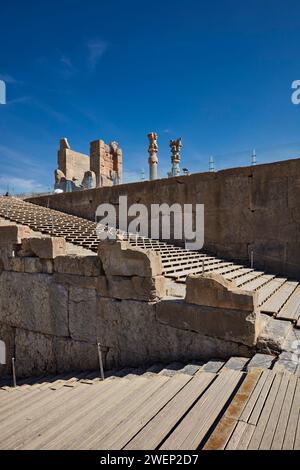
top-left (97, 298), bottom-right (250, 367)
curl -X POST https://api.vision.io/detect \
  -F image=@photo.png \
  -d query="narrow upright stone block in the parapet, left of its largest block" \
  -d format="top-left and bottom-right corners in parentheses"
top-left (69, 287), bottom-right (97, 343)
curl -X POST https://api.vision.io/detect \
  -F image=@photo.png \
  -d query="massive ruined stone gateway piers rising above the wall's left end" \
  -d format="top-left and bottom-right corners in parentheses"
top-left (54, 138), bottom-right (122, 192)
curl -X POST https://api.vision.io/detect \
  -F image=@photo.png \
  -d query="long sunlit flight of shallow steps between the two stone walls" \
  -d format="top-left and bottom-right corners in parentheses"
top-left (0, 197), bottom-right (300, 326)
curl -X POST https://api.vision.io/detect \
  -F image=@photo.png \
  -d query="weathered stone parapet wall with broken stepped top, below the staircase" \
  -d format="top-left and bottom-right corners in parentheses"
top-left (0, 225), bottom-right (259, 377)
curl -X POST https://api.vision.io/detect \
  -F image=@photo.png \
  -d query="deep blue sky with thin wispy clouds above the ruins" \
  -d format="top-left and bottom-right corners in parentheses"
top-left (0, 0), bottom-right (300, 192)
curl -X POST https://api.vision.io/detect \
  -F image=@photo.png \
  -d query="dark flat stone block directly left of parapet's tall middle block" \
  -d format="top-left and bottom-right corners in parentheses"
top-left (54, 255), bottom-right (103, 276)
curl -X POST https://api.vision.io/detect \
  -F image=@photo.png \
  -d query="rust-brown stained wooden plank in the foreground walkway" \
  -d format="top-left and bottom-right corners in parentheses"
top-left (204, 369), bottom-right (262, 450)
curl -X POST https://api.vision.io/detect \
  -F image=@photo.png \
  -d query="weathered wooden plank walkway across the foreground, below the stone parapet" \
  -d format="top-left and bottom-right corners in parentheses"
top-left (0, 364), bottom-right (300, 450)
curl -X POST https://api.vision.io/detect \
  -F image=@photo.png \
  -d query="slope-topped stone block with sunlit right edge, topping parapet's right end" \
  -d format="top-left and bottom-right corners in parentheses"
top-left (185, 273), bottom-right (257, 312)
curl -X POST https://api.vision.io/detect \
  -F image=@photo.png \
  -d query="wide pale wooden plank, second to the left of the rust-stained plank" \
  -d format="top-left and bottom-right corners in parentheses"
top-left (124, 372), bottom-right (216, 450)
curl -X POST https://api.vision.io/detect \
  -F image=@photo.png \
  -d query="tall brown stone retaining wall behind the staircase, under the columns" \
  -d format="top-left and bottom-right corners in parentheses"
top-left (29, 159), bottom-right (300, 279)
